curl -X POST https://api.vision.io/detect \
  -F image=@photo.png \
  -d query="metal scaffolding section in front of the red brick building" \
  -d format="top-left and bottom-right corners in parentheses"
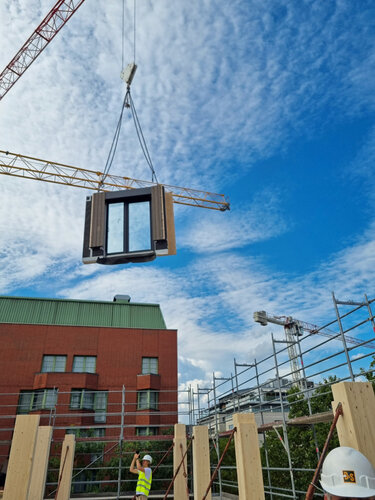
top-left (0, 387), bottom-right (193, 499)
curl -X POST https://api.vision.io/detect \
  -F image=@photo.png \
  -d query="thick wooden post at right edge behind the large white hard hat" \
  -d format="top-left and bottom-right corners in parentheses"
top-left (332, 382), bottom-right (375, 465)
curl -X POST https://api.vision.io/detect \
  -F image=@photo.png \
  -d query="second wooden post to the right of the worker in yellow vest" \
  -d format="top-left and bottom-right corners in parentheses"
top-left (192, 425), bottom-right (212, 500)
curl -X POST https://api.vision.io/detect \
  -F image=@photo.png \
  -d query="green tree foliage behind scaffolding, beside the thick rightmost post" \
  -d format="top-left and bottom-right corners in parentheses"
top-left (261, 377), bottom-right (339, 499)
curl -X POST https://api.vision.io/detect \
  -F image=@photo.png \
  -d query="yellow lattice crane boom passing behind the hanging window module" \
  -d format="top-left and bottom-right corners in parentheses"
top-left (0, 150), bottom-right (230, 212)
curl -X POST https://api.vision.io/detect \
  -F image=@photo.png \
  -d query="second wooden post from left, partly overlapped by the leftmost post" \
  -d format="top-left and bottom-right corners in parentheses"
top-left (28, 425), bottom-right (52, 500)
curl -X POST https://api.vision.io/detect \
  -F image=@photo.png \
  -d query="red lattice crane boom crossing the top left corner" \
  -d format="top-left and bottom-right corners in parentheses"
top-left (0, 0), bottom-right (85, 100)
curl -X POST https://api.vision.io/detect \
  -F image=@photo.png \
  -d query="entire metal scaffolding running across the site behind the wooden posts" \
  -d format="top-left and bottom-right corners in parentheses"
top-left (0, 294), bottom-right (375, 499)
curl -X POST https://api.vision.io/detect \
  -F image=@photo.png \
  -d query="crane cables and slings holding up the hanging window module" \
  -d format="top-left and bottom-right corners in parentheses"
top-left (98, 0), bottom-right (158, 191)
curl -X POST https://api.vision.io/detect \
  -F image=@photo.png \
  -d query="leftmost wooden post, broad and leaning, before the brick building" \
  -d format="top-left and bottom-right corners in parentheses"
top-left (3, 415), bottom-right (40, 500)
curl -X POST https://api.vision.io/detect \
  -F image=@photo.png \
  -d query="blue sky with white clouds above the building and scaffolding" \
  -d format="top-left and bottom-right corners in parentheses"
top-left (0, 0), bottom-right (375, 386)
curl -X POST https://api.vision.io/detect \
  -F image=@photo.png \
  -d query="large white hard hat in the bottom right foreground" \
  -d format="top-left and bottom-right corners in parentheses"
top-left (320, 446), bottom-right (375, 498)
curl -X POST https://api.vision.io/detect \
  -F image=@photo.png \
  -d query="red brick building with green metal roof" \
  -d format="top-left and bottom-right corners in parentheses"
top-left (0, 296), bottom-right (178, 476)
